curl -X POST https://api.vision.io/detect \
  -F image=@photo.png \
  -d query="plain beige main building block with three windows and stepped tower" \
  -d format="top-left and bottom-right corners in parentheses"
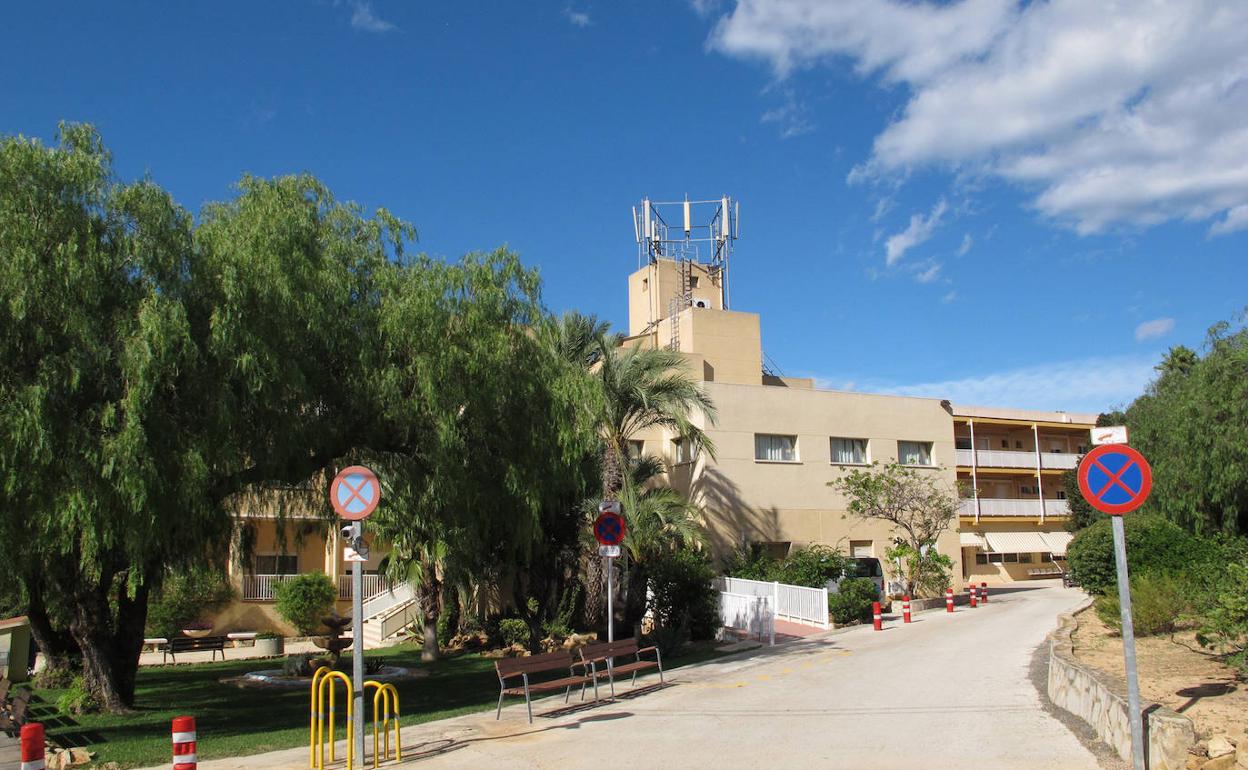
top-left (628, 258), bottom-right (963, 589)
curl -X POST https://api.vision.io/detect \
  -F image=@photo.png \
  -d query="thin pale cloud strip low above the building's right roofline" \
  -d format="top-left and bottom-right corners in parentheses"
top-left (816, 353), bottom-right (1161, 412)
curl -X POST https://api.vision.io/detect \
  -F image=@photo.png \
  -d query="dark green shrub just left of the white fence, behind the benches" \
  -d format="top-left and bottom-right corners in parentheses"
top-left (646, 550), bottom-right (720, 639)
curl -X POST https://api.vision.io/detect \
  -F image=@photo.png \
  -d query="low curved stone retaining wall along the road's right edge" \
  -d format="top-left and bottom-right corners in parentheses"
top-left (1048, 605), bottom-right (1196, 770)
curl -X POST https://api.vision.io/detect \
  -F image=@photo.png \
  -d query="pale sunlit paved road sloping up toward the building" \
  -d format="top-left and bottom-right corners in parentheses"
top-left (194, 588), bottom-right (1097, 770)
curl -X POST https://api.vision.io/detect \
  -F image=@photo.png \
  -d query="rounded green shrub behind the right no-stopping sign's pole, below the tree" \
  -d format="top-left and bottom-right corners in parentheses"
top-left (1066, 514), bottom-right (1226, 594)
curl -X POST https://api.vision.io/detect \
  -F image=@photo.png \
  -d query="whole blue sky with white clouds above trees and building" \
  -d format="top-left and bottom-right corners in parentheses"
top-left (0, 0), bottom-right (1248, 411)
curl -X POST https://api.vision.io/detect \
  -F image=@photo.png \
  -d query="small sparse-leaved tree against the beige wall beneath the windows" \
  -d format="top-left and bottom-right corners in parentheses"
top-left (827, 463), bottom-right (958, 595)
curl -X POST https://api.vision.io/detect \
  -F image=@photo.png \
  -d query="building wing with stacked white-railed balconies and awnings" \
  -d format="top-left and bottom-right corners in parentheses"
top-left (953, 406), bottom-right (1097, 583)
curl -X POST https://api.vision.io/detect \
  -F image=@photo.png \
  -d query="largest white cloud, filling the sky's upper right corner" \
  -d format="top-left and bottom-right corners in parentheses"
top-left (709, 0), bottom-right (1248, 235)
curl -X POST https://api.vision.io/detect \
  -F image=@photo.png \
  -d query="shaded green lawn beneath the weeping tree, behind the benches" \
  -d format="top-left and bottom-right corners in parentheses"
top-left (30, 644), bottom-right (719, 768)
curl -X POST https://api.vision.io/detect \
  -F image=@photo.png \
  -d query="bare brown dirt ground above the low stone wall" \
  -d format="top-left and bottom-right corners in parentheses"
top-left (1072, 610), bottom-right (1248, 740)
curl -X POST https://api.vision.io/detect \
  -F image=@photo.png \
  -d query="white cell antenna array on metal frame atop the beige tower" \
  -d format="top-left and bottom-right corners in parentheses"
top-left (633, 195), bottom-right (741, 309)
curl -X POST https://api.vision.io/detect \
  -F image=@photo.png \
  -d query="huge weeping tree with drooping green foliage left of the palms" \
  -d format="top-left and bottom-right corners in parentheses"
top-left (0, 126), bottom-right (589, 711)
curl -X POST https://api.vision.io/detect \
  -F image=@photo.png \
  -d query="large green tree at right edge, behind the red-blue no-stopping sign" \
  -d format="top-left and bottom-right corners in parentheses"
top-left (1127, 323), bottom-right (1248, 534)
